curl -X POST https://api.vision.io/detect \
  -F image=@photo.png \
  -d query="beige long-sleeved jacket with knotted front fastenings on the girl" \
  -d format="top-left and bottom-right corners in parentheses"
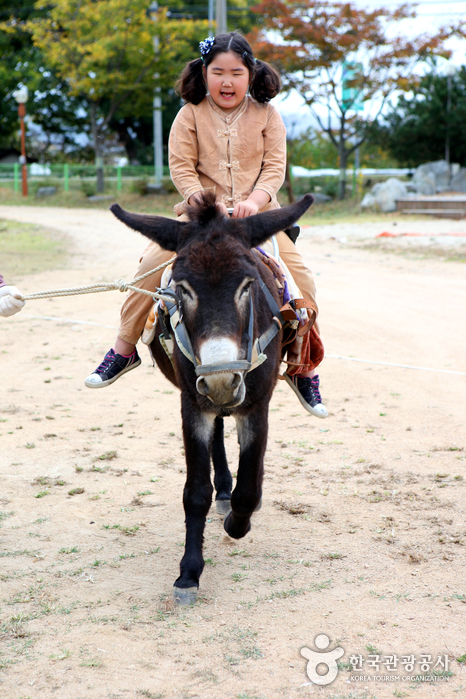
top-left (169, 95), bottom-right (286, 216)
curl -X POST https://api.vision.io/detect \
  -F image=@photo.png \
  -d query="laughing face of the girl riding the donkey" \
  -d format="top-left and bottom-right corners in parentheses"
top-left (205, 51), bottom-right (249, 112)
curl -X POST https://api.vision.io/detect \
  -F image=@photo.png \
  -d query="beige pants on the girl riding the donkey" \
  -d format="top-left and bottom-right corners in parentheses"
top-left (118, 227), bottom-right (318, 345)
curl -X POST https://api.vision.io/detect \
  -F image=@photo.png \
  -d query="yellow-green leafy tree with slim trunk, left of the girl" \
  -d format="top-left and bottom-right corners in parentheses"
top-left (27, 0), bottom-right (207, 192)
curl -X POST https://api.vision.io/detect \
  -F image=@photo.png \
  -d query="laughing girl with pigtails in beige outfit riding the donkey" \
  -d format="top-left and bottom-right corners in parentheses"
top-left (85, 32), bottom-right (328, 417)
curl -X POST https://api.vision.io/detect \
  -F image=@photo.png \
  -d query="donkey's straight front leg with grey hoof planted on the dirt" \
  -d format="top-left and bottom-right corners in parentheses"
top-left (174, 395), bottom-right (215, 605)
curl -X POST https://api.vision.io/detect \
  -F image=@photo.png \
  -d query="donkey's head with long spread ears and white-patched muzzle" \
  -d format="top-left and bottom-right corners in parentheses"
top-left (111, 194), bottom-right (313, 409)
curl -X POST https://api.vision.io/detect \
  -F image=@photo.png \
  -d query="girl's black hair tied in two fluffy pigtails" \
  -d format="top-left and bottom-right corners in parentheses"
top-left (176, 32), bottom-right (281, 104)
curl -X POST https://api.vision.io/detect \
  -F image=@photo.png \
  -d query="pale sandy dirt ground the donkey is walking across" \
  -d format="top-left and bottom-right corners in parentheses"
top-left (0, 206), bottom-right (466, 699)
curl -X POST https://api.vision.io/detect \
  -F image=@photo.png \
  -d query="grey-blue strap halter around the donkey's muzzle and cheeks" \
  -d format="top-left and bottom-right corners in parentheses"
top-left (159, 278), bottom-right (285, 377)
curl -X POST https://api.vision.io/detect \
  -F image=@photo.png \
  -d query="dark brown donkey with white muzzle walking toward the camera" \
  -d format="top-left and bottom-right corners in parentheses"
top-left (111, 194), bottom-right (314, 605)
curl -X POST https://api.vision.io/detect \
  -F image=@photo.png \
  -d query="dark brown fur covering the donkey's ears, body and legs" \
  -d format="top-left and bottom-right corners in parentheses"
top-left (112, 195), bottom-right (313, 601)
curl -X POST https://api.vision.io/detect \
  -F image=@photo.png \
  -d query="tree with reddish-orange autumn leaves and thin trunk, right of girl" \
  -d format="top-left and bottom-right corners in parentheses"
top-left (249, 0), bottom-right (454, 199)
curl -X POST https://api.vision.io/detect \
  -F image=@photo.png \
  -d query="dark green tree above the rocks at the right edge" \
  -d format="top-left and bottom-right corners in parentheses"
top-left (369, 66), bottom-right (466, 167)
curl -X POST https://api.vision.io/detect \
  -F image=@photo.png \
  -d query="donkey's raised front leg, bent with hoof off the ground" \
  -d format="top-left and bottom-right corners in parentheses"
top-left (223, 405), bottom-right (268, 539)
